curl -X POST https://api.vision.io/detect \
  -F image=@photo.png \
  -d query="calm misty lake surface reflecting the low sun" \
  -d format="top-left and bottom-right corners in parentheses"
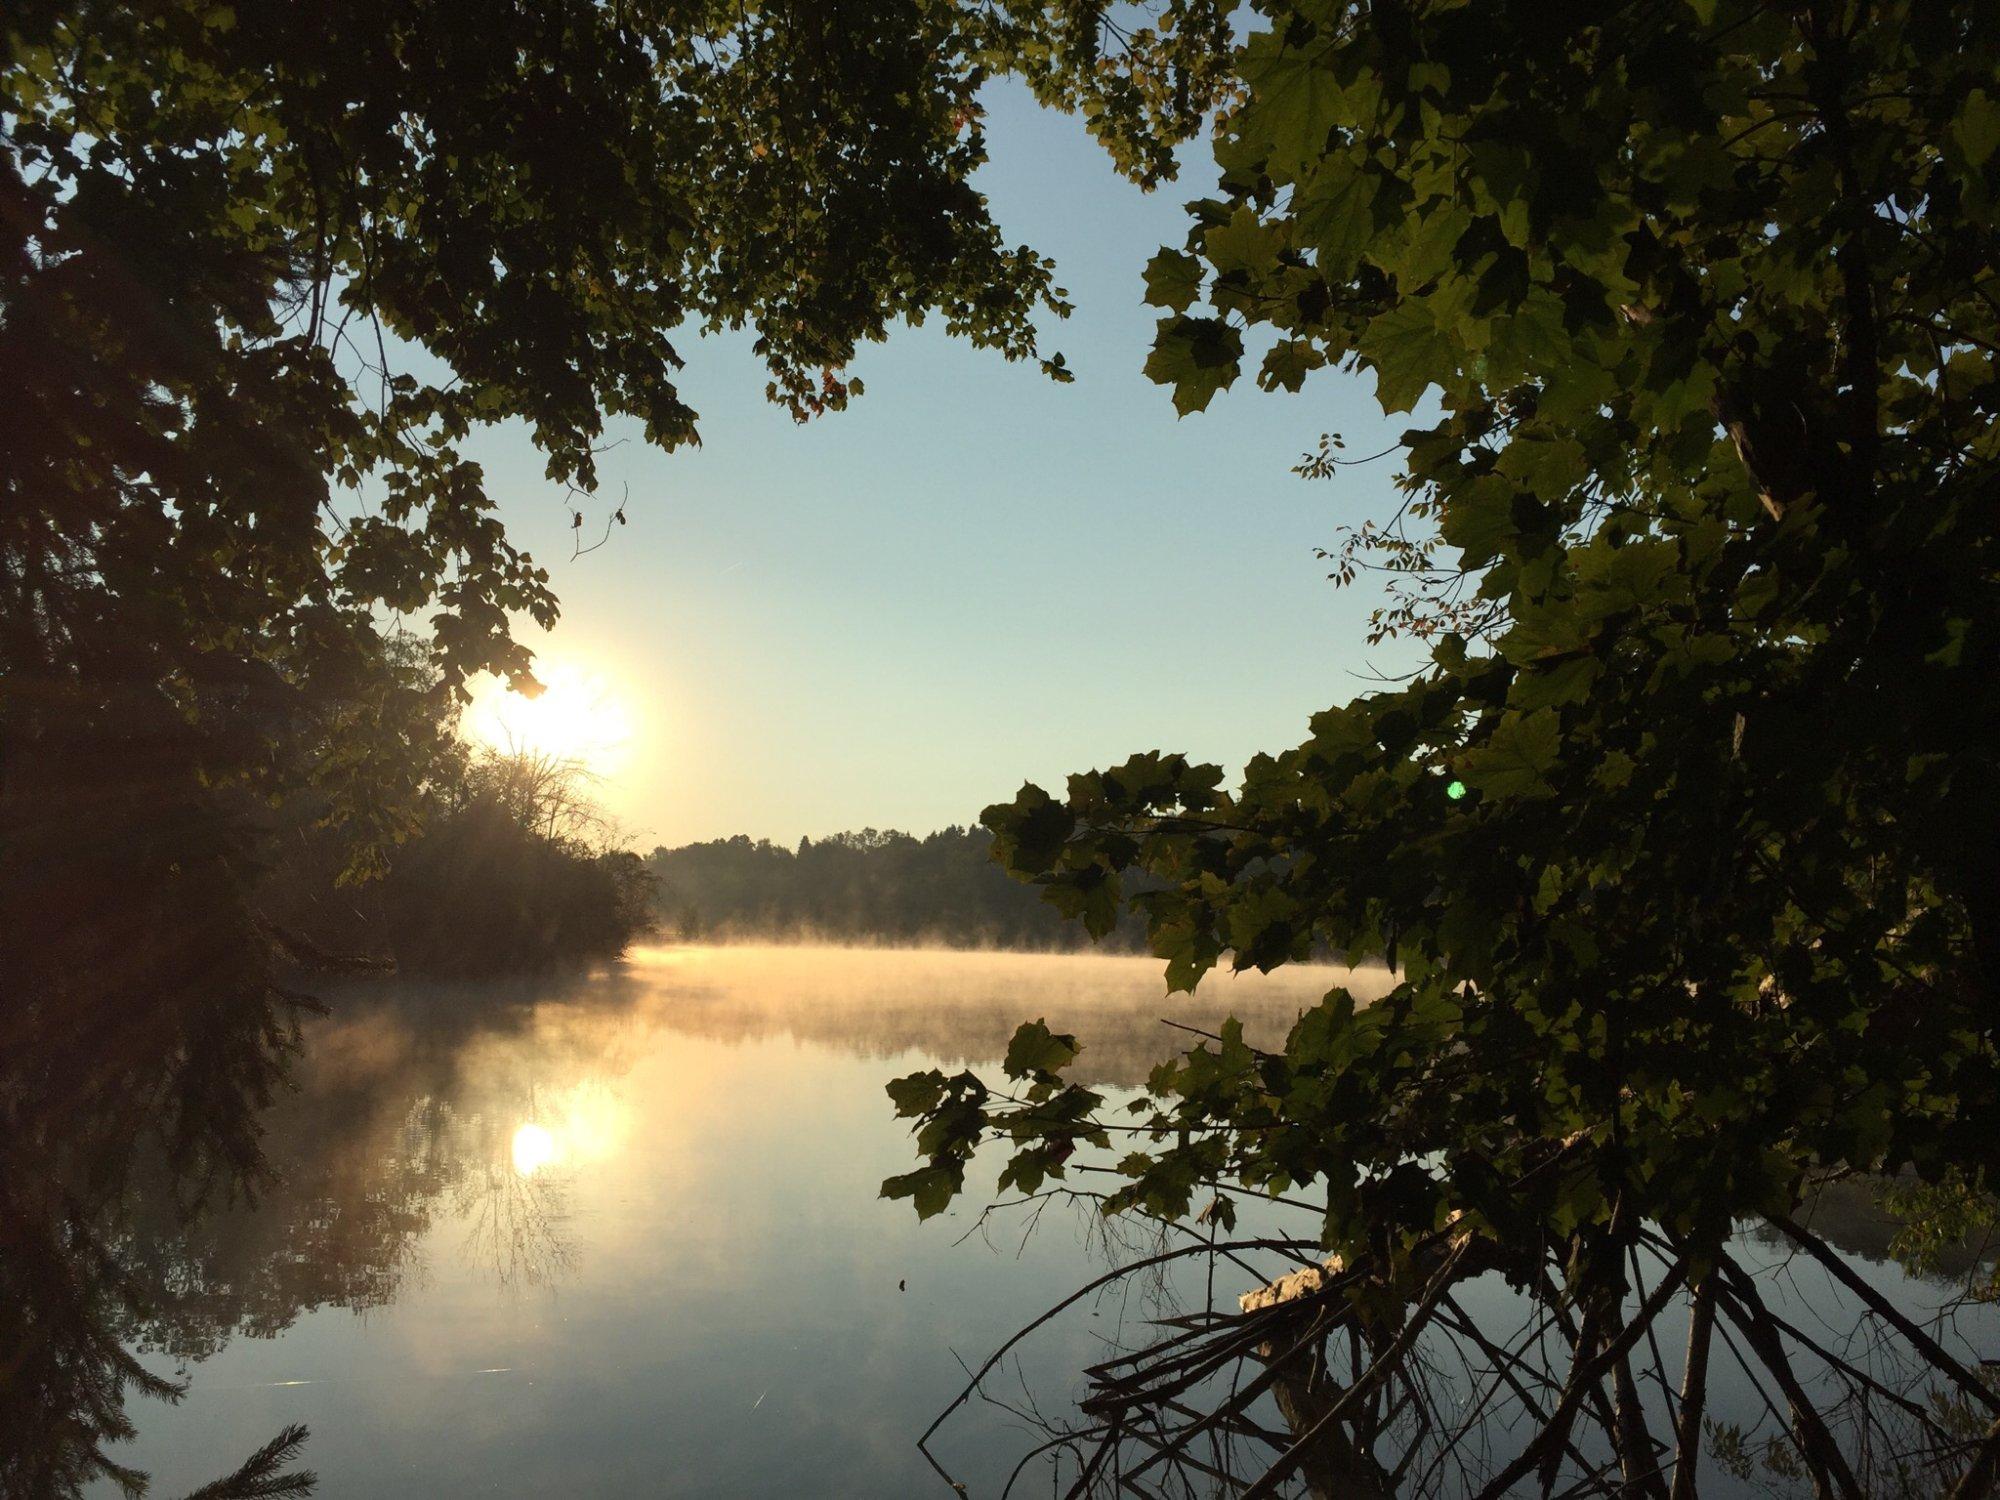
top-left (82, 946), bottom-right (2000, 1496)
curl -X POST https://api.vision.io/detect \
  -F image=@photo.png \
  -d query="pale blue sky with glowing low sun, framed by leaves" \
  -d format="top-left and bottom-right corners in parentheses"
top-left (458, 88), bottom-right (1412, 850)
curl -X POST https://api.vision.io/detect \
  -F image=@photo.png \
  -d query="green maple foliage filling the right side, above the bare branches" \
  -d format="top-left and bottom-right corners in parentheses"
top-left (892, 0), bottom-right (2000, 1296)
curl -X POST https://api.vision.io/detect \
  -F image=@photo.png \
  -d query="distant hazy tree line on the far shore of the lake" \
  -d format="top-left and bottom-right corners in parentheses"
top-left (646, 826), bottom-right (1144, 950)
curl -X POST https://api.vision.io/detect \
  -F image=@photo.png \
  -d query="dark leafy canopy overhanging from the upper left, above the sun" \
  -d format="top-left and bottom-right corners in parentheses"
top-left (0, 0), bottom-right (1224, 836)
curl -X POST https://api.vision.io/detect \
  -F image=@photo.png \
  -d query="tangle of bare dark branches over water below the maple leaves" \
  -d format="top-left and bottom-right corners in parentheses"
top-left (922, 1188), bottom-right (2000, 1500)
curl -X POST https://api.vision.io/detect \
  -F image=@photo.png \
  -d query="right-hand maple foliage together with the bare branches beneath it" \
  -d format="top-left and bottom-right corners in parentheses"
top-left (884, 0), bottom-right (2000, 1500)
